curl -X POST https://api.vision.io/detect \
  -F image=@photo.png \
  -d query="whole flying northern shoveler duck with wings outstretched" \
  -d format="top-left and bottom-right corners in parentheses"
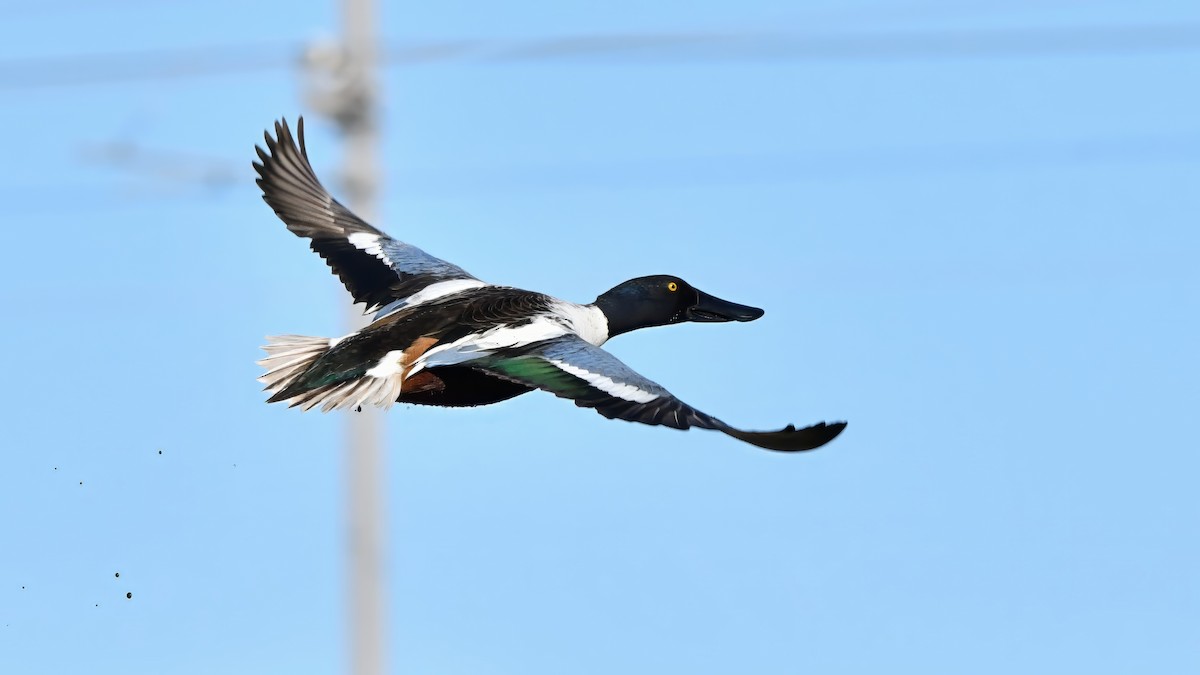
top-left (253, 118), bottom-right (846, 452)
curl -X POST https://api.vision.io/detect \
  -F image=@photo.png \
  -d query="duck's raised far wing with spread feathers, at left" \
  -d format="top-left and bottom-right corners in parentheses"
top-left (254, 118), bottom-right (486, 311)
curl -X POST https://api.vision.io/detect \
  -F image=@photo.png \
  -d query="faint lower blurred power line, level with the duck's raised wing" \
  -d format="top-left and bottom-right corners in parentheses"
top-left (30, 133), bottom-right (1200, 215)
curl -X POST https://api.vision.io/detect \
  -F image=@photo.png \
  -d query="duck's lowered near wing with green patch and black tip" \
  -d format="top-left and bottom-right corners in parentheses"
top-left (464, 335), bottom-right (846, 452)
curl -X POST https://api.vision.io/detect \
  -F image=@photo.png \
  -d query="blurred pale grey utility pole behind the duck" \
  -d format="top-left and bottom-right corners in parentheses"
top-left (306, 0), bottom-right (388, 675)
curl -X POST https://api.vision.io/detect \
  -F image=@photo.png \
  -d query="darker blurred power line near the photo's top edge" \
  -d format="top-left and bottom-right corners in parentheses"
top-left (0, 23), bottom-right (1200, 90)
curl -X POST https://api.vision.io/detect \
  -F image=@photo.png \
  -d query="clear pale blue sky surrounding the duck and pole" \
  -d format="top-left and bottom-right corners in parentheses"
top-left (0, 0), bottom-right (1200, 675)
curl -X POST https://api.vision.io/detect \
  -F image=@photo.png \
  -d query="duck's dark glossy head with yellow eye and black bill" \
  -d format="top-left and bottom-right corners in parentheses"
top-left (595, 274), bottom-right (763, 338)
